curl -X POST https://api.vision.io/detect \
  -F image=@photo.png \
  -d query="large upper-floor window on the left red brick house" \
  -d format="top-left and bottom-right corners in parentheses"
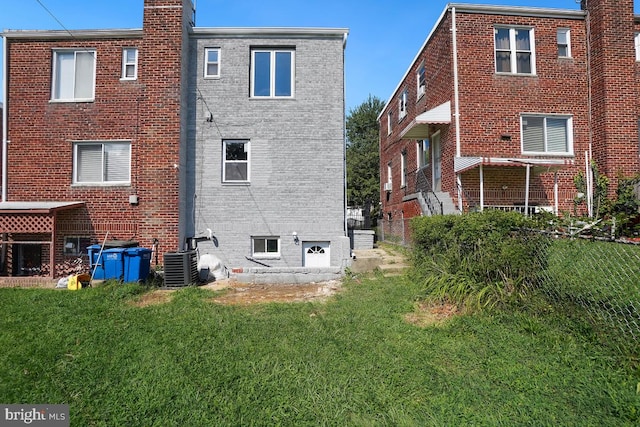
top-left (51, 50), bottom-right (96, 101)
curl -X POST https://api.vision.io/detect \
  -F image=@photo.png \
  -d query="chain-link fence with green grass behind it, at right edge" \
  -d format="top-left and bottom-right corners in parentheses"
top-left (533, 233), bottom-right (640, 353)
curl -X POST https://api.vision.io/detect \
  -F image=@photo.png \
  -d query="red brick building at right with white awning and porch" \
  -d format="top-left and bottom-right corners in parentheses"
top-left (379, 0), bottom-right (640, 246)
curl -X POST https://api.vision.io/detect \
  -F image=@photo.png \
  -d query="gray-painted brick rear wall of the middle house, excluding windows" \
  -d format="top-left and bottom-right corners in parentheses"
top-left (185, 29), bottom-right (350, 270)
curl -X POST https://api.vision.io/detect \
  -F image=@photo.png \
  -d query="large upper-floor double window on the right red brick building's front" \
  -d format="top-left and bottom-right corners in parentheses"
top-left (494, 27), bottom-right (536, 74)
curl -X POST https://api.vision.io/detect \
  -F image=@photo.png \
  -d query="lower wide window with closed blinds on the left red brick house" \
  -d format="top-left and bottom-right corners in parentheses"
top-left (73, 141), bottom-right (131, 185)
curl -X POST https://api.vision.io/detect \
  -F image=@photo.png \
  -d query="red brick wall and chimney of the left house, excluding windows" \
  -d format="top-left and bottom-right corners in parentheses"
top-left (6, 0), bottom-right (191, 274)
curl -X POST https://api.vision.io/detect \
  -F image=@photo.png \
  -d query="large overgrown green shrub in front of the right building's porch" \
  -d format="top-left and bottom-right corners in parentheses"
top-left (411, 210), bottom-right (548, 308)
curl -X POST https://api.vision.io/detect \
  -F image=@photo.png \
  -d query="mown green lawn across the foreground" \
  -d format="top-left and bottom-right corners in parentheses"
top-left (0, 276), bottom-right (640, 426)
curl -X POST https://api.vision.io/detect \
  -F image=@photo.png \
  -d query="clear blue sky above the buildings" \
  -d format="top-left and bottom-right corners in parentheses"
top-left (0, 0), bottom-right (638, 114)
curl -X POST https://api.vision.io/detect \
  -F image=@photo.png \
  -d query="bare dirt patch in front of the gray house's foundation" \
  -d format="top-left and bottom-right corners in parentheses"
top-left (211, 280), bottom-right (341, 305)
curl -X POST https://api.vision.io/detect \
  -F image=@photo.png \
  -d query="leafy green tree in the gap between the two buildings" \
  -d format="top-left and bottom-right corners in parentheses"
top-left (346, 95), bottom-right (384, 211)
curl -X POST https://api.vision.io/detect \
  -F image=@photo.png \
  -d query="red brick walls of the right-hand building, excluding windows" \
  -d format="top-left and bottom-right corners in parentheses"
top-left (380, 0), bottom-right (640, 242)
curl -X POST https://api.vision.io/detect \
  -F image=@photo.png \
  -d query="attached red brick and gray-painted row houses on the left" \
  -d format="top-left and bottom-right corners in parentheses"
top-left (0, 0), bottom-right (349, 277)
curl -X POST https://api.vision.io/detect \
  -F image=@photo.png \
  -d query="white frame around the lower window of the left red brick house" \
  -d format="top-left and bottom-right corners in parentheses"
top-left (73, 140), bottom-right (131, 186)
